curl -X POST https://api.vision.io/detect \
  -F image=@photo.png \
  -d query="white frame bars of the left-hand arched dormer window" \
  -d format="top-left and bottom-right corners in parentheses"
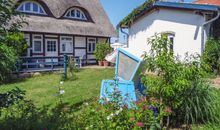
top-left (17, 1), bottom-right (47, 15)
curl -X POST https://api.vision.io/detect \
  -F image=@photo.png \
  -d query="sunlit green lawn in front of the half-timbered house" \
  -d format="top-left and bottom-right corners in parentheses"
top-left (0, 69), bottom-right (114, 107)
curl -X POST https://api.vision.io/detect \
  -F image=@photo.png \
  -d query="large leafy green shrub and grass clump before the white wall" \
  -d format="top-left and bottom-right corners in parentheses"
top-left (142, 34), bottom-right (219, 127)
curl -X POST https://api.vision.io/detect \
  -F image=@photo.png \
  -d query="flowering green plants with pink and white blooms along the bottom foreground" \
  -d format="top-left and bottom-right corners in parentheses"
top-left (0, 90), bottom-right (171, 130)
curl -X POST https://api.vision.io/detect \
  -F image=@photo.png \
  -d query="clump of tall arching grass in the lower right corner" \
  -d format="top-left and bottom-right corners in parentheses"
top-left (178, 80), bottom-right (220, 124)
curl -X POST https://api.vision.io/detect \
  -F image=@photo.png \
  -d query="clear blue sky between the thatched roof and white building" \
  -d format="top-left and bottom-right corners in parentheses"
top-left (100, 0), bottom-right (193, 43)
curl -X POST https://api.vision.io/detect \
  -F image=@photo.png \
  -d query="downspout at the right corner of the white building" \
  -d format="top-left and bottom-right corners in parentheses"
top-left (201, 9), bottom-right (220, 55)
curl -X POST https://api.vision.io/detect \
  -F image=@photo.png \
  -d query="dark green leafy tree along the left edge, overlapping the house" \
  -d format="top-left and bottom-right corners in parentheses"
top-left (0, 0), bottom-right (27, 83)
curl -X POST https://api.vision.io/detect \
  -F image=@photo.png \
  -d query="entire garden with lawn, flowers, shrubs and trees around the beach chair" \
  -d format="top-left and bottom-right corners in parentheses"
top-left (0, 0), bottom-right (220, 130)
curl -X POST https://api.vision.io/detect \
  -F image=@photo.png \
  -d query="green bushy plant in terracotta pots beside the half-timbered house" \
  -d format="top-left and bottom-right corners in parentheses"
top-left (94, 43), bottom-right (112, 66)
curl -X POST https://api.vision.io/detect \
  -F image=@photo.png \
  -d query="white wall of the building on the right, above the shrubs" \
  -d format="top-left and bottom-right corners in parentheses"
top-left (128, 9), bottom-right (205, 57)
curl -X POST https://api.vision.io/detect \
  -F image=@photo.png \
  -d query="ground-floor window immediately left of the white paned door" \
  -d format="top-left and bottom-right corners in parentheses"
top-left (33, 35), bottom-right (43, 53)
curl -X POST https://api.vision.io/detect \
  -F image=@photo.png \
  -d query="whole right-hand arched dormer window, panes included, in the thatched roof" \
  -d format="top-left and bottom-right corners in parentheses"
top-left (64, 8), bottom-right (87, 20)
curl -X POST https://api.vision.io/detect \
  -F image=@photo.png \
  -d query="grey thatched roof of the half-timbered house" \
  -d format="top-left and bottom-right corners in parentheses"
top-left (15, 0), bottom-right (116, 37)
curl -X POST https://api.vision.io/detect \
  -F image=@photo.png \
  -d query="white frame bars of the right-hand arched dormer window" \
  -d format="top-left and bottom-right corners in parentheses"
top-left (64, 8), bottom-right (87, 20)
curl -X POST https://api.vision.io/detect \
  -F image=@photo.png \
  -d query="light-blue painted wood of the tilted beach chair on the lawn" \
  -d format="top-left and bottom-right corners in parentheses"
top-left (100, 49), bottom-right (144, 107)
